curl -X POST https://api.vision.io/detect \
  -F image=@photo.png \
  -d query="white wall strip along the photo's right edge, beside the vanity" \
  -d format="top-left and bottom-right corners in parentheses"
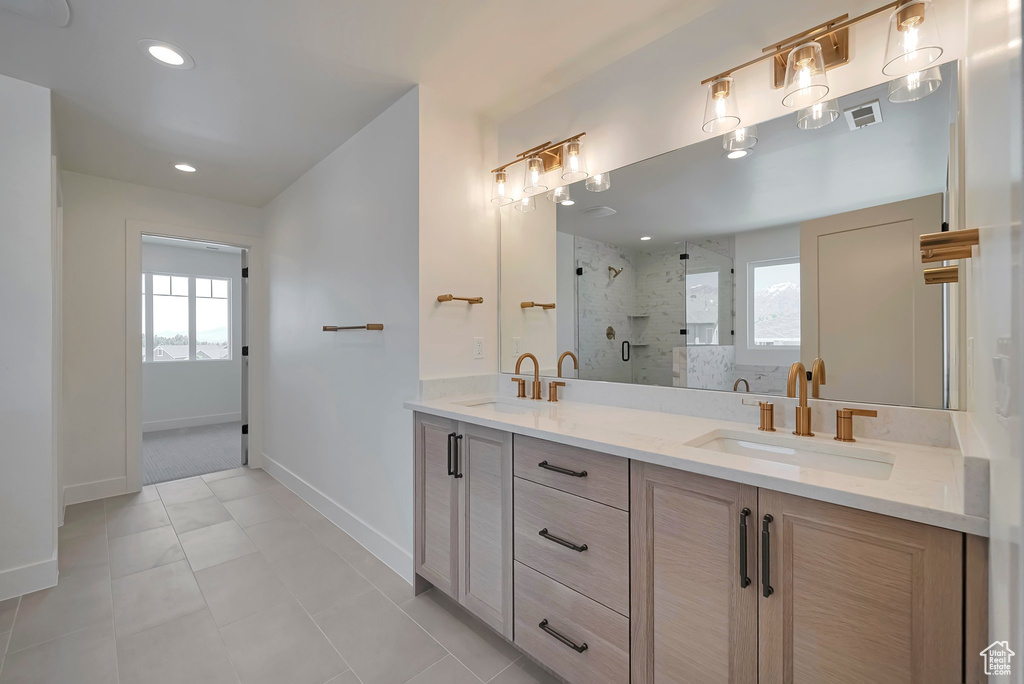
top-left (962, 0), bottom-right (1024, 655)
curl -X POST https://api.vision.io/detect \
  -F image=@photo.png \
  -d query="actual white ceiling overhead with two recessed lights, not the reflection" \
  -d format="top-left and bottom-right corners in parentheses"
top-left (0, 0), bottom-right (723, 207)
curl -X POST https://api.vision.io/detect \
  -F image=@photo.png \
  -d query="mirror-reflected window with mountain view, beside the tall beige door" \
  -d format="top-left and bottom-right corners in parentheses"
top-left (746, 258), bottom-right (800, 349)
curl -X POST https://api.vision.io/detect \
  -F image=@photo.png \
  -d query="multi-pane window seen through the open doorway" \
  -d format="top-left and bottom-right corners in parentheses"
top-left (142, 273), bottom-right (231, 362)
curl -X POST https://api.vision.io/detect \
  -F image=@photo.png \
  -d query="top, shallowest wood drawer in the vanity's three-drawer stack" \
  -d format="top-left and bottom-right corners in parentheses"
top-left (513, 434), bottom-right (630, 511)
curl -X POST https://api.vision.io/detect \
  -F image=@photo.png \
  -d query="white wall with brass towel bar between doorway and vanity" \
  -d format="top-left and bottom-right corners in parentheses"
top-left (263, 85), bottom-right (423, 580)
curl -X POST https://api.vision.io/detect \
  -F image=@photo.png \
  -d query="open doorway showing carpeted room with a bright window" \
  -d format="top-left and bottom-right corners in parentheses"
top-left (135, 233), bottom-right (249, 485)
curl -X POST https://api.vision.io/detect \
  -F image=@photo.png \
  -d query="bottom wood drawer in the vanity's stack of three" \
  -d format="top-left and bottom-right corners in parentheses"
top-left (515, 562), bottom-right (630, 684)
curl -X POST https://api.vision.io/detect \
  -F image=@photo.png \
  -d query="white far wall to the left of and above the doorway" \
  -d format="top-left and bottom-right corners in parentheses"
top-left (60, 171), bottom-right (263, 503)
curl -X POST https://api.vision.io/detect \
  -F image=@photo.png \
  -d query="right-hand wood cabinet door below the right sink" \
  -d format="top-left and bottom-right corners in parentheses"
top-left (756, 489), bottom-right (963, 684)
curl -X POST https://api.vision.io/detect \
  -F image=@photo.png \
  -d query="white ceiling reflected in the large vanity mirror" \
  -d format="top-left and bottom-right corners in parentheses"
top-left (557, 62), bottom-right (956, 248)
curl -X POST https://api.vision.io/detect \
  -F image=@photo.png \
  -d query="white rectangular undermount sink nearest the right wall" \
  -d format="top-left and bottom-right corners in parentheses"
top-left (687, 430), bottom-right (896, 480)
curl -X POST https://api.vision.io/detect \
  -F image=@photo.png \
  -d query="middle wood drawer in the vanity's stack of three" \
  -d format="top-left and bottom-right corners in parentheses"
top-left (514, 477), bottom-right (630, 615)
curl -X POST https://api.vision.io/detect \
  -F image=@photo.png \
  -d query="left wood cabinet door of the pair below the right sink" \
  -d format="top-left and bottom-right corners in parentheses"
top-left (630, 461), bottom-right (758, 684)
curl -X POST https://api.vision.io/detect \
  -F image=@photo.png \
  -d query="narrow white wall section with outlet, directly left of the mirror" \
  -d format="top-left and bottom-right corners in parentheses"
top-left (418, 86), bottom-right (498, 379)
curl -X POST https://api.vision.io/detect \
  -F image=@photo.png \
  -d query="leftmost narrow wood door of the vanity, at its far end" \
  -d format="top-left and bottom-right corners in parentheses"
top-left (415, 414), bottom-right (459, 599)
